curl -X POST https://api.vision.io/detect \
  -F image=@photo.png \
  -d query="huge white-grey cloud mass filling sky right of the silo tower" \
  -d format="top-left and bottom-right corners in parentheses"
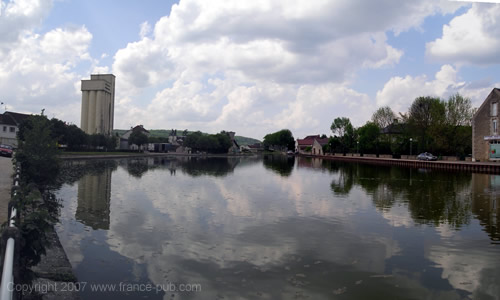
top-left (112, 0), bottom-right (459, 137)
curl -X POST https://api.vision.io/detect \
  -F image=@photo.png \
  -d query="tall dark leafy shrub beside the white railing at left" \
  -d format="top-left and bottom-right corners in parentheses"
top-left (2, 114), bottom-right (77, 299)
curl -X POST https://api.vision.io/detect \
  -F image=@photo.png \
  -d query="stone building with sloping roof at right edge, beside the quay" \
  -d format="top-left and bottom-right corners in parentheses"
top-left (472, 88), bottom-right (500, 161)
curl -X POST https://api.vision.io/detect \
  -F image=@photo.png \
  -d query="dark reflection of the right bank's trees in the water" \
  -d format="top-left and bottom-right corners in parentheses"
top-left (299, 158), bottom-right (500, 241)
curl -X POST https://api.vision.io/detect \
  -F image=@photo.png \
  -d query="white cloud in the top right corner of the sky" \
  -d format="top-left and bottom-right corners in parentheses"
top-left (426, 4), bottom-right (500, 65)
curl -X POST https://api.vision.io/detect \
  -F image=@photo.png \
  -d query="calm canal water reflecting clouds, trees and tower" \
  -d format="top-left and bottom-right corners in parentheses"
top-left (57, 156), bottom-right (500, 300)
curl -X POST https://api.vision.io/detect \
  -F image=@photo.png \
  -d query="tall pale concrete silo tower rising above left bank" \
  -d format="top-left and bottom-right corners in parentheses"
top-left (80, 74), bottom-right (115, 135)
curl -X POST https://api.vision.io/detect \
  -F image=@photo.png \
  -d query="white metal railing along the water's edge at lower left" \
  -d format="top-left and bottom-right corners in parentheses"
top-left (0, 167), bottom-right (20, 300)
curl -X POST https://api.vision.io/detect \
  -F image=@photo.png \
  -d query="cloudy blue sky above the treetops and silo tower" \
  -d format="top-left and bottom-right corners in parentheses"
top-left (0, 0), bottom-right (500, 139)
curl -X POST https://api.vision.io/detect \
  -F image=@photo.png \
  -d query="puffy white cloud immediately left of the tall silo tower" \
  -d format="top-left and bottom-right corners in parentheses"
top-left (0, 23), bottom-right (92, 120)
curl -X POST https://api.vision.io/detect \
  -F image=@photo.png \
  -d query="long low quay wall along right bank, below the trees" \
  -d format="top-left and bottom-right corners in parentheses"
top-left (300, 155), bottom-right (500, 174)
